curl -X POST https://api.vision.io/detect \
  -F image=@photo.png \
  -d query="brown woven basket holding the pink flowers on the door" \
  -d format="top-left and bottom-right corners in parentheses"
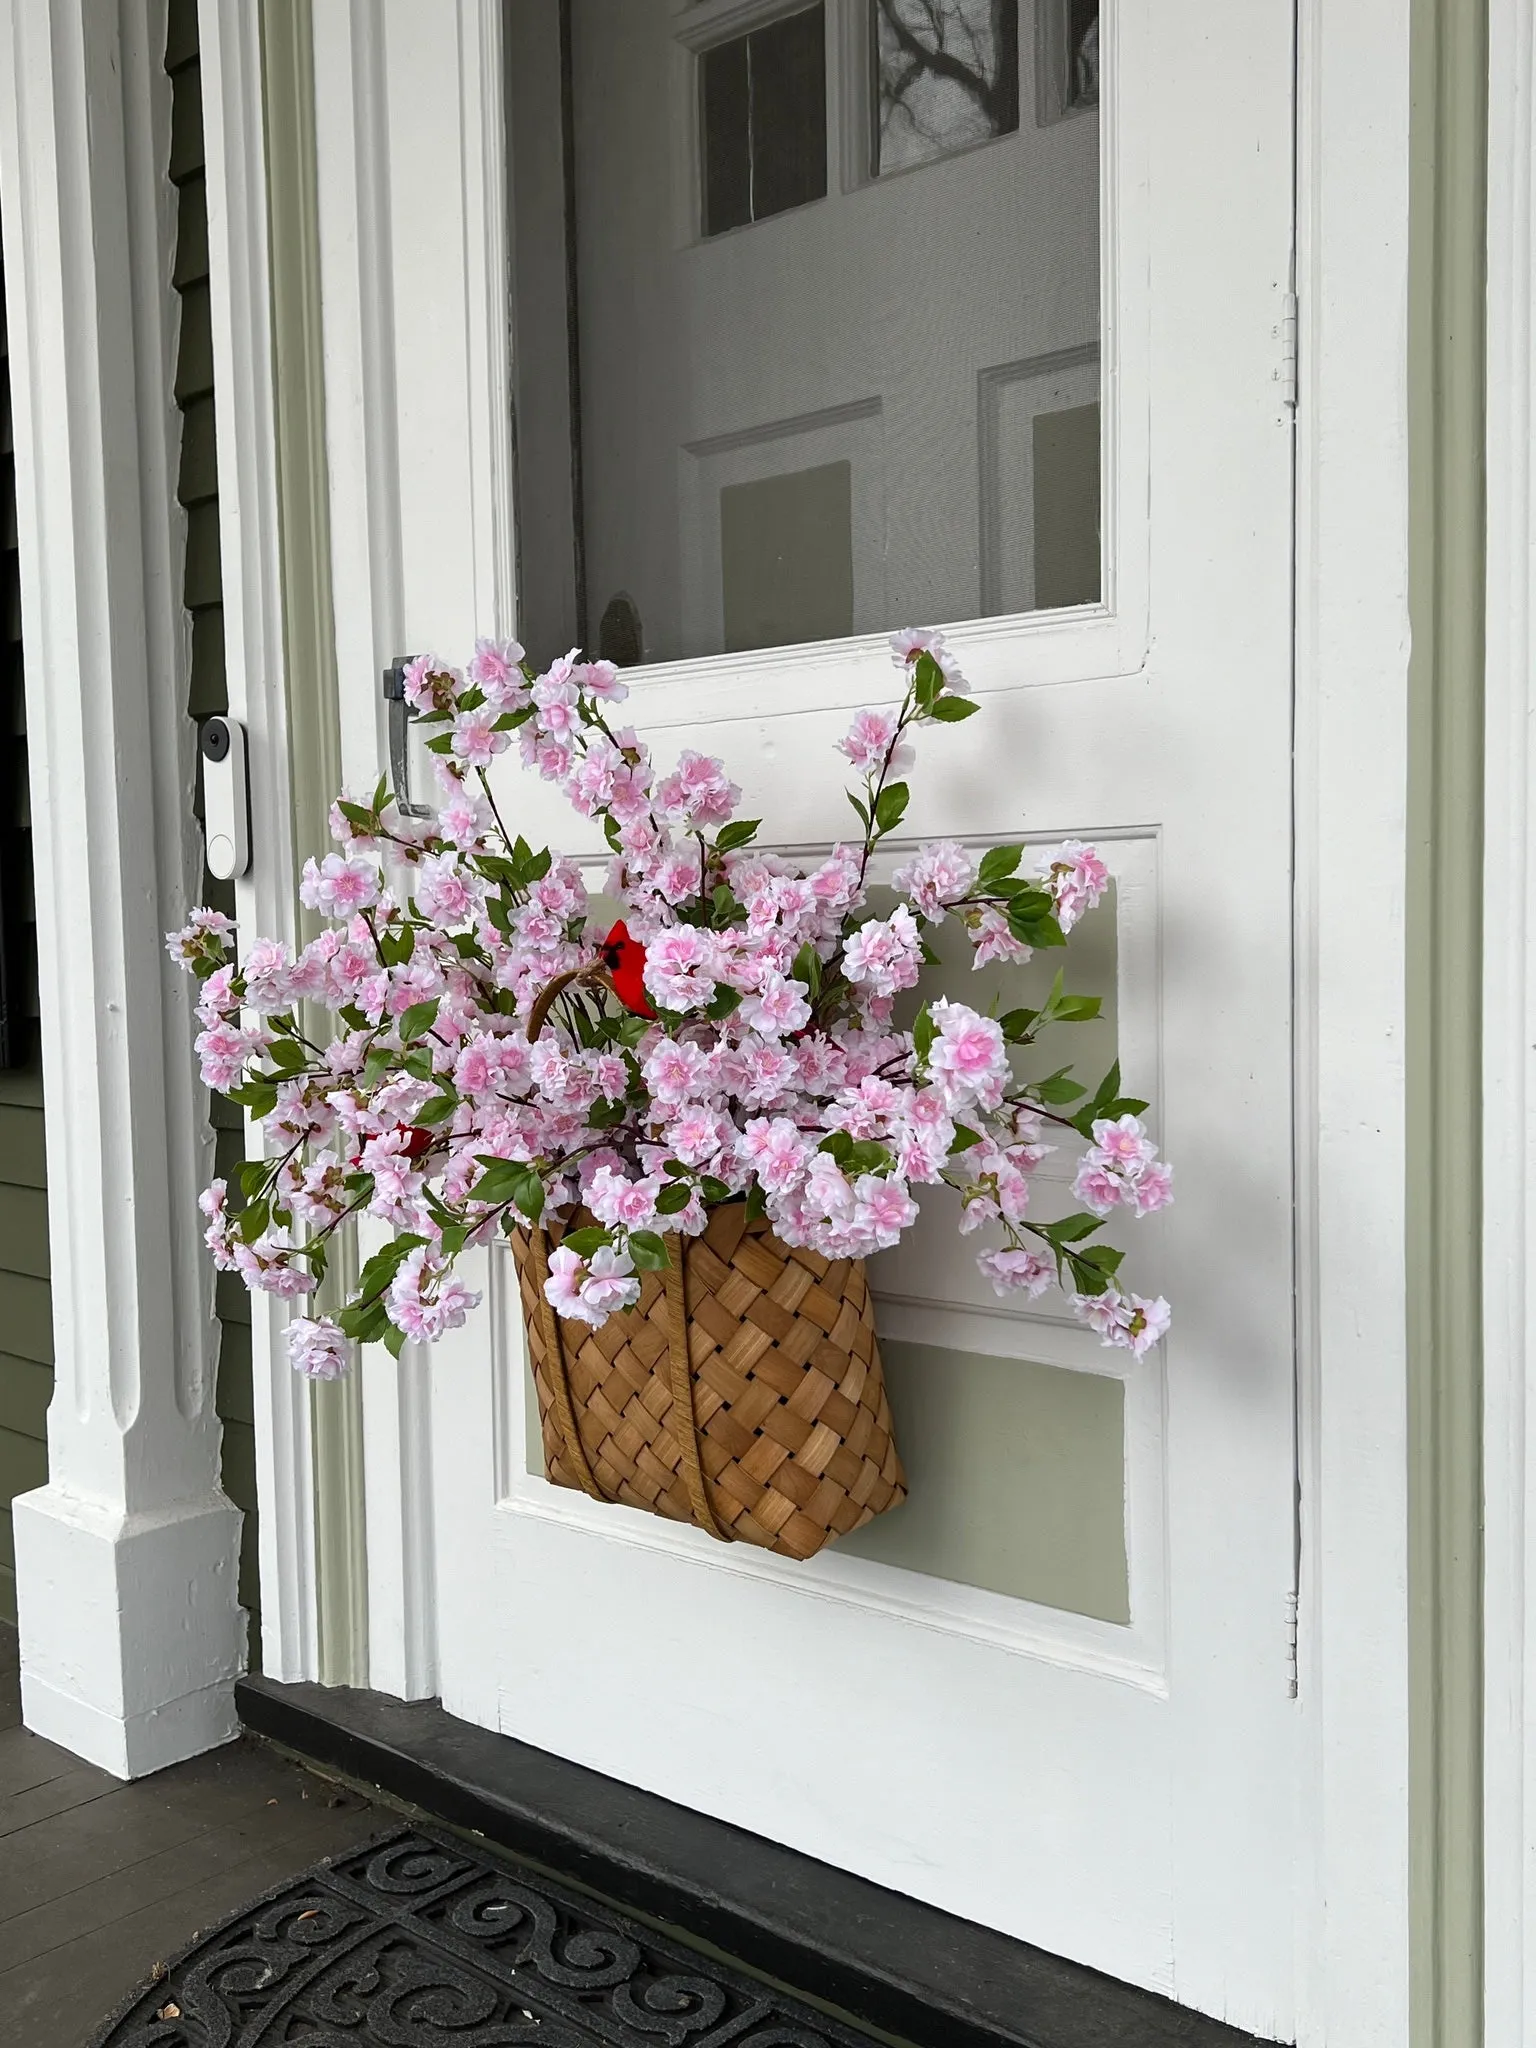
top-left (512, 1202), bottom-right (907, 1559)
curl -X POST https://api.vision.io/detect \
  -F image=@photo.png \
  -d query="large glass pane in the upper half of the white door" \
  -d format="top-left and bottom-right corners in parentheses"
top-left (504, 0), bottom-right (1102, 666)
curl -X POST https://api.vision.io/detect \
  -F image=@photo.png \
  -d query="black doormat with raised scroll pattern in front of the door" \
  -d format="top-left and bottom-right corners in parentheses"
top-left (92, 1829), bottom-right (868, 2048)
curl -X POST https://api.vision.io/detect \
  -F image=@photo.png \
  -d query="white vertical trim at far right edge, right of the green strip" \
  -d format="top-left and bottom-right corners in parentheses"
top-left (1483, 0), bottom-right (1536, 2048)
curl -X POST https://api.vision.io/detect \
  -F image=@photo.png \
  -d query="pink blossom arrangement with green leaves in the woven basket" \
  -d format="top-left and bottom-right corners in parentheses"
top-left (168, 633), bottom-right (1171, 1378)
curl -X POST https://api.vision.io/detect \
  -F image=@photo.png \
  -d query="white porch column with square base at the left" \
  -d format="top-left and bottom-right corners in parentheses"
top-left (0, 0), bottom-right (244, 1778)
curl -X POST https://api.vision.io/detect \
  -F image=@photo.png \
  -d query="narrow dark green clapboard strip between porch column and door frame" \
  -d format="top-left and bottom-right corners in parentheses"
top-left (167, 0), bottom-right (260, 1663)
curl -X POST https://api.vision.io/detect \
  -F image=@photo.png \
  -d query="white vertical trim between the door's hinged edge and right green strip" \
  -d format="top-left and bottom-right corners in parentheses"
top-left (1296, 0), bottom-right (1409, 2048)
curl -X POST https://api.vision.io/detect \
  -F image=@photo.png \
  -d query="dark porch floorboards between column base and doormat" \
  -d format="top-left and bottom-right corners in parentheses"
top-left (0, 1622), bottom-right (382, 2048)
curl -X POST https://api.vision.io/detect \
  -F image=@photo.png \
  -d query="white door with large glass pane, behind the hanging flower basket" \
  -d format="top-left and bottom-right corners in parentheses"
top-left (317, 0), bottom-right (1307, 2038)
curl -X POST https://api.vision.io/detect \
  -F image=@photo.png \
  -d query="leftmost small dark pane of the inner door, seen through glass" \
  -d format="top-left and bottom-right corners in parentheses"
top-left (698, 6), bottom-right (827, 236)
